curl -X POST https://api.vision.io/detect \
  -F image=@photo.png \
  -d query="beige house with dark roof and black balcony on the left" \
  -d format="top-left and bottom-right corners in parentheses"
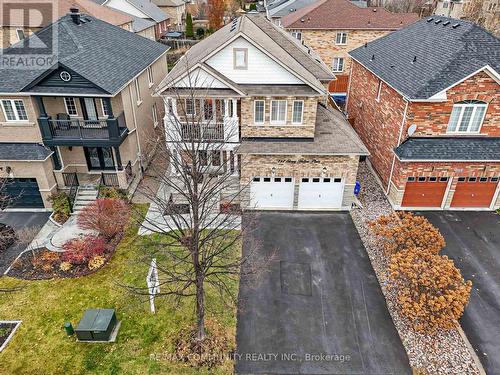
top-left (0, 9), bottom-right (168, 208)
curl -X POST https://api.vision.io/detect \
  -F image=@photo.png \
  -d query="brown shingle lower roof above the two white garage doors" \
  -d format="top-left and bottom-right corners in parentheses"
top-left (238, 104), bottom-right (369, 155)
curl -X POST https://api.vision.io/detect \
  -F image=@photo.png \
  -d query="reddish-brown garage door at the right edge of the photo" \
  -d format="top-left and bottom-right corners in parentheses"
top-left (451, 177), bottom-right (498, 208)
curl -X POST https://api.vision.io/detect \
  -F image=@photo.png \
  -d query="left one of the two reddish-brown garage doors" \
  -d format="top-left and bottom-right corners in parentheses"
top-left (401, 177), bottom-right (448, 207)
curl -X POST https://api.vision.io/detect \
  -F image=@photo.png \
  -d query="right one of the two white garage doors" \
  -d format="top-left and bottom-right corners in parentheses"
top-left (298, 177), bottom-right (344, 209)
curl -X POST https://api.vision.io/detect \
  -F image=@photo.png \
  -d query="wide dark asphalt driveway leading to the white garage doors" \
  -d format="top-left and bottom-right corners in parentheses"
top-left (235, 212), bottom-right (410, 375)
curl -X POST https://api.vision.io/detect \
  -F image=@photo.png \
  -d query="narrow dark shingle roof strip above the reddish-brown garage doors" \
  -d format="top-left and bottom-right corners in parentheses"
top-left (394, 137), bottom-right (500, 161)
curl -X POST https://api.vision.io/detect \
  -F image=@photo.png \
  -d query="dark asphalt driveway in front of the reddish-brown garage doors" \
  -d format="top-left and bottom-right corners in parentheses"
top-left (418, 211), bottom-right (500, 374)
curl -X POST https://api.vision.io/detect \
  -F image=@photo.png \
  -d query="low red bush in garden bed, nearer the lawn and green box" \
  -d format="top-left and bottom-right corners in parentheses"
top-left (61, 235), bottom-right (109, 265)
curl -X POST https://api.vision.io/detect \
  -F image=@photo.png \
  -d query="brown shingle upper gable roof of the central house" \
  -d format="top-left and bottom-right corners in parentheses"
top-left (159, 14), bottom-right (334, 92)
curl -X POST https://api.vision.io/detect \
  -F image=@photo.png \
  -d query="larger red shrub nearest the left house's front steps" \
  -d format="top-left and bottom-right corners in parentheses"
top-left (77, 198), bottom-right (130, 239)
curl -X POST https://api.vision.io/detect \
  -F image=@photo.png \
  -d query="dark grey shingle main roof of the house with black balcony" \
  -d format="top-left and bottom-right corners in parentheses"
top-left (0, 15), bottom-right (169, 95)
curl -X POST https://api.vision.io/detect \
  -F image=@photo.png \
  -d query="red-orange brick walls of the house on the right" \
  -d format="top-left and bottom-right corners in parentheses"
top-left (347, 62), bottom-right (500, 208)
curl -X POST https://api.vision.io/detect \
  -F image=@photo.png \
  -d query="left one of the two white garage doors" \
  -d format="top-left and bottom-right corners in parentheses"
top-left (250, 177), bottom-right (294, 209)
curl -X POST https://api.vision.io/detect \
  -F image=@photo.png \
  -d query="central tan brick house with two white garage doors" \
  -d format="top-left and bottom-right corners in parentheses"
top-left (158, 13), bottom-right (368, 210)
